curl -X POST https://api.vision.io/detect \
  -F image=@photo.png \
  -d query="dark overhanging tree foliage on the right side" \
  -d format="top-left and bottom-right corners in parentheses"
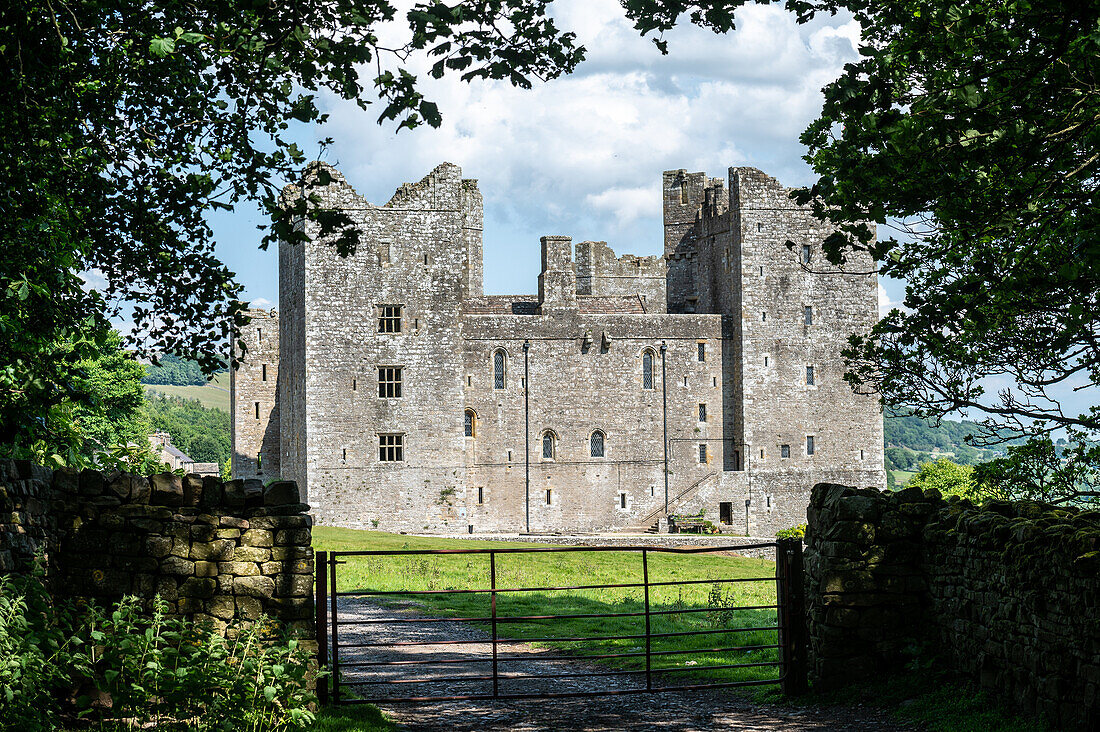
top-left (624, 0), bottom-right (1100, 493)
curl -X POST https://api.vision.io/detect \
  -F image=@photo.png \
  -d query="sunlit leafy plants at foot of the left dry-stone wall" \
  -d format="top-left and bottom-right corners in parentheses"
top-left (0, 575), bottom-right (315, 731)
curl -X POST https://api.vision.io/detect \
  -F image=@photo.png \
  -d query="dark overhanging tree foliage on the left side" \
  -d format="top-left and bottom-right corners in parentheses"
top-left (0, 0), bottom-right (583, 451)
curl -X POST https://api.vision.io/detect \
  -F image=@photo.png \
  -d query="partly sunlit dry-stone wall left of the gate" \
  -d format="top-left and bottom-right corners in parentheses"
top-left (0, 461), bottom-right (314, 638)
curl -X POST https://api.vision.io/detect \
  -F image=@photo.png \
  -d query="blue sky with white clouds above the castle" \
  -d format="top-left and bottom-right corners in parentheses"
top-left (207, 0), bottom-right (901, 307)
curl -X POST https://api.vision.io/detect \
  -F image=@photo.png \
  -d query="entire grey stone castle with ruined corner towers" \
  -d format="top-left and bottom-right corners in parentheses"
top-left (232, 163), bottom-right (886, 536)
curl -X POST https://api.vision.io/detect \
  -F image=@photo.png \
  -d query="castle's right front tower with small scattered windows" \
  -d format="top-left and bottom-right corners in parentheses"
top-left (729, 168), bottom-right (886, 517)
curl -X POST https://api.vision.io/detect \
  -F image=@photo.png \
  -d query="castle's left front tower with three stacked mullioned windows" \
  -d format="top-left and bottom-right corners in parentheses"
top-left (288, 164), bottom-right (481, 529)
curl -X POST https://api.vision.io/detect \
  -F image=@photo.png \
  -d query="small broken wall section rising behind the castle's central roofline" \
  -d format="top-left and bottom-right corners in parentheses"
top-left (575, 241), bottom-right (668, 313)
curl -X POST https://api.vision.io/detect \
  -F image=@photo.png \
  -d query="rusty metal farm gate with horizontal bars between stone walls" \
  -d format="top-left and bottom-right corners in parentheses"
top-left (316, 539), bottom-right (806, 704)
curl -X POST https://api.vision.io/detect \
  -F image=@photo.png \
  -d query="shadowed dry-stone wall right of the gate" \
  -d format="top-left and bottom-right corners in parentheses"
top-left (805, 483), bottom-right (1100, 730)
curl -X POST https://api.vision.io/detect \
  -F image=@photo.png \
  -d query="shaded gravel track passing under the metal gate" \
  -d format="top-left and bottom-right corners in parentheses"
top-left (339, 598), bottom-right (911, 732)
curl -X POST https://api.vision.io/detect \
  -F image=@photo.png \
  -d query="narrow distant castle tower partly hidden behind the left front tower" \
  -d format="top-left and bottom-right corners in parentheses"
top-left (229, 309), bottom-right (281, 479)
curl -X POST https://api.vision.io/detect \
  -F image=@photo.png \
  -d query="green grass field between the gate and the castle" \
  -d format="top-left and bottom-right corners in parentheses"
top-left (314, 526), bottom-right (779, 684)
